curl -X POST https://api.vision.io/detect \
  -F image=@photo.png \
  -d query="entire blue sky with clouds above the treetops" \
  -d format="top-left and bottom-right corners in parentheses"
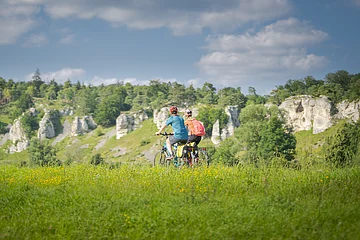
top-left (0, 0), bottom-right (360, 94)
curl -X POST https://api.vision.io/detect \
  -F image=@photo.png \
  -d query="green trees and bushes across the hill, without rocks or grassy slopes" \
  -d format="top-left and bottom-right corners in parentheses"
top-left (0, 69), bottom-right (360, 168)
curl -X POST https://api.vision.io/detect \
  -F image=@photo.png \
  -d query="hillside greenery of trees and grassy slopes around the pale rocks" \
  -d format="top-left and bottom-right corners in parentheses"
top-left (0, 70), bottom-right (360, 165)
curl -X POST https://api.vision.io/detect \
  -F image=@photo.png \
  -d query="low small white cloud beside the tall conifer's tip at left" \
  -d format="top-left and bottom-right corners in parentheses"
top-left (25, 68), bottom-right (86, 83)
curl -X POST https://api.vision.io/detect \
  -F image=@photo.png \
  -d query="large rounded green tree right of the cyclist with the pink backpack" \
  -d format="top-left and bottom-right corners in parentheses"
top-left (235, 105), bottom-right (296, 162)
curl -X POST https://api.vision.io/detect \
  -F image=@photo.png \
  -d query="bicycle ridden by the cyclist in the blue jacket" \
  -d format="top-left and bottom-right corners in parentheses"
top-left (153, 132), bottom-right (189, 167)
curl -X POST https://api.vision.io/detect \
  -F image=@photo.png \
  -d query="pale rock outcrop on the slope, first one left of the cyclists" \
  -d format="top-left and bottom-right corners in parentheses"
top-left (116, 112), bottom-right (148, 139)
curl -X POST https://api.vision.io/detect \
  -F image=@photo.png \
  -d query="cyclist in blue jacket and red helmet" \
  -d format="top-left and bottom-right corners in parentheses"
top-left (155, 106), bottom-right (188, 159)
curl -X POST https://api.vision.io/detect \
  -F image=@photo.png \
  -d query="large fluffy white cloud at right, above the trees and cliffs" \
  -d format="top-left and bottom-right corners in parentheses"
top-left (197, 18), bottom-right (328, 89)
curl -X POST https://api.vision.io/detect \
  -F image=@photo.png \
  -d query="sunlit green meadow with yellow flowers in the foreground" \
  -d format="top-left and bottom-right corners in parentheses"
top-left (0, 165), bottom-right (360, 239)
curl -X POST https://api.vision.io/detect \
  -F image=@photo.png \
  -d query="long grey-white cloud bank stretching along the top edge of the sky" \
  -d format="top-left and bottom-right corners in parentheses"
top-left (40, 0), bottom-right (291, 35)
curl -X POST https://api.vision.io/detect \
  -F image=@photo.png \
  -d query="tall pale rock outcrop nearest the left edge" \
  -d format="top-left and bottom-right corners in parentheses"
top-left (9, 118), bottom-right (30, 154)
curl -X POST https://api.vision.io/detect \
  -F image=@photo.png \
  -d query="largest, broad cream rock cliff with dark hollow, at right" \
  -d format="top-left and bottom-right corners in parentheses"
top-left (279, 95), bottom-right (333, 134)
